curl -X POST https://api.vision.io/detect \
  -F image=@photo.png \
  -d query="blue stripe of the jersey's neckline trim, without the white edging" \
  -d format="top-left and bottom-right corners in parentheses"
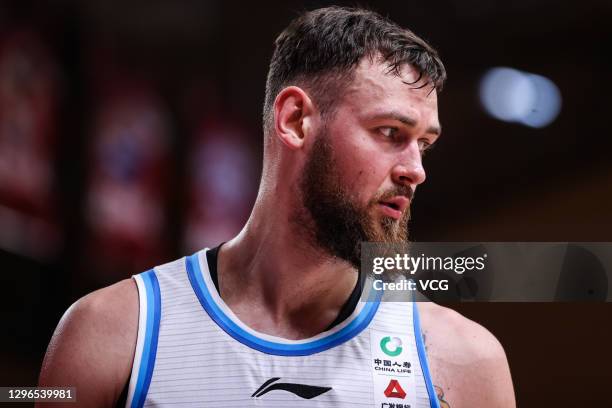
top-left (186, 253), bottom-right (380, 356)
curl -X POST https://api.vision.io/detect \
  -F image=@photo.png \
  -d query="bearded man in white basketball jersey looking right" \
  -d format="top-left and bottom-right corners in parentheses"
top-left (40, 7), bottom-right (515, 408)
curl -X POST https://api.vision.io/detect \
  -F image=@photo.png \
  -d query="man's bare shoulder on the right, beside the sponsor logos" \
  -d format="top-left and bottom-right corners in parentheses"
top-left (418, 302), bottom-right (516, 407)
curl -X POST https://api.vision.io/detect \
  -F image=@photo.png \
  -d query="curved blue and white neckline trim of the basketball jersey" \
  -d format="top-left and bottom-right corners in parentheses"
top-left (185, 249), bottom-right (380, 356)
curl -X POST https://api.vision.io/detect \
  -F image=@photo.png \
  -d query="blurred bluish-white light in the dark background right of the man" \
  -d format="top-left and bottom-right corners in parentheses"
top-left (480, 67), bottom-right (561, 128)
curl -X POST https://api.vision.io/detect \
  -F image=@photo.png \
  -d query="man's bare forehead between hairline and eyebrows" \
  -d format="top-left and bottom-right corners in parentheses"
top-left (342, 58), bottom-right (439, 122)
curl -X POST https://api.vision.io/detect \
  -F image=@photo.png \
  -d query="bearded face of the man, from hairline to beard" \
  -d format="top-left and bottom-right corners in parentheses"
top-left (300, 59), bottom-right (440, 267)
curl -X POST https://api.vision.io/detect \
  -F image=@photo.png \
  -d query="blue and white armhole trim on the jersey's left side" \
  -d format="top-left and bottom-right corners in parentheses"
top-left (125, 269), bottom-right (161, 408)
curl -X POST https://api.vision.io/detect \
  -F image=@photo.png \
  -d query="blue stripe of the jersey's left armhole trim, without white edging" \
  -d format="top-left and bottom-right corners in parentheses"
top-left (132, 269), bottom-right (161, 408)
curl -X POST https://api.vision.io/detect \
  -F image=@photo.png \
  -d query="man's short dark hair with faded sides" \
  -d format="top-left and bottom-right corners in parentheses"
top-left (263, 6), bottom-right (446, 131)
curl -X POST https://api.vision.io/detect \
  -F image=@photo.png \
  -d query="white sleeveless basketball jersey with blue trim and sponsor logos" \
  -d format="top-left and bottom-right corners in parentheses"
top-left (127, 250), bottom-right (439, 408)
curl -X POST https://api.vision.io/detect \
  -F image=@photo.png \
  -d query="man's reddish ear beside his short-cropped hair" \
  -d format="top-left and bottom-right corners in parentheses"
top-left (274, 86), bottom-right (315, 149)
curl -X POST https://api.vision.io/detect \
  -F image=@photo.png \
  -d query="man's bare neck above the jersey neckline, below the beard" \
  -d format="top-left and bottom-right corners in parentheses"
top-left (218, 190), bottom-right (358, 339)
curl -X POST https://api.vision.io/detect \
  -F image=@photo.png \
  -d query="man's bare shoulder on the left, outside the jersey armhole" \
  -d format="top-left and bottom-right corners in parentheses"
top-left (39, 279), bottom-right (139, 407)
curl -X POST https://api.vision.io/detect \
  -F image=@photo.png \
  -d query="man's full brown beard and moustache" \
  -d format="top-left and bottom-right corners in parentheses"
top-left (294, 132), bottom-right (412, 268)
